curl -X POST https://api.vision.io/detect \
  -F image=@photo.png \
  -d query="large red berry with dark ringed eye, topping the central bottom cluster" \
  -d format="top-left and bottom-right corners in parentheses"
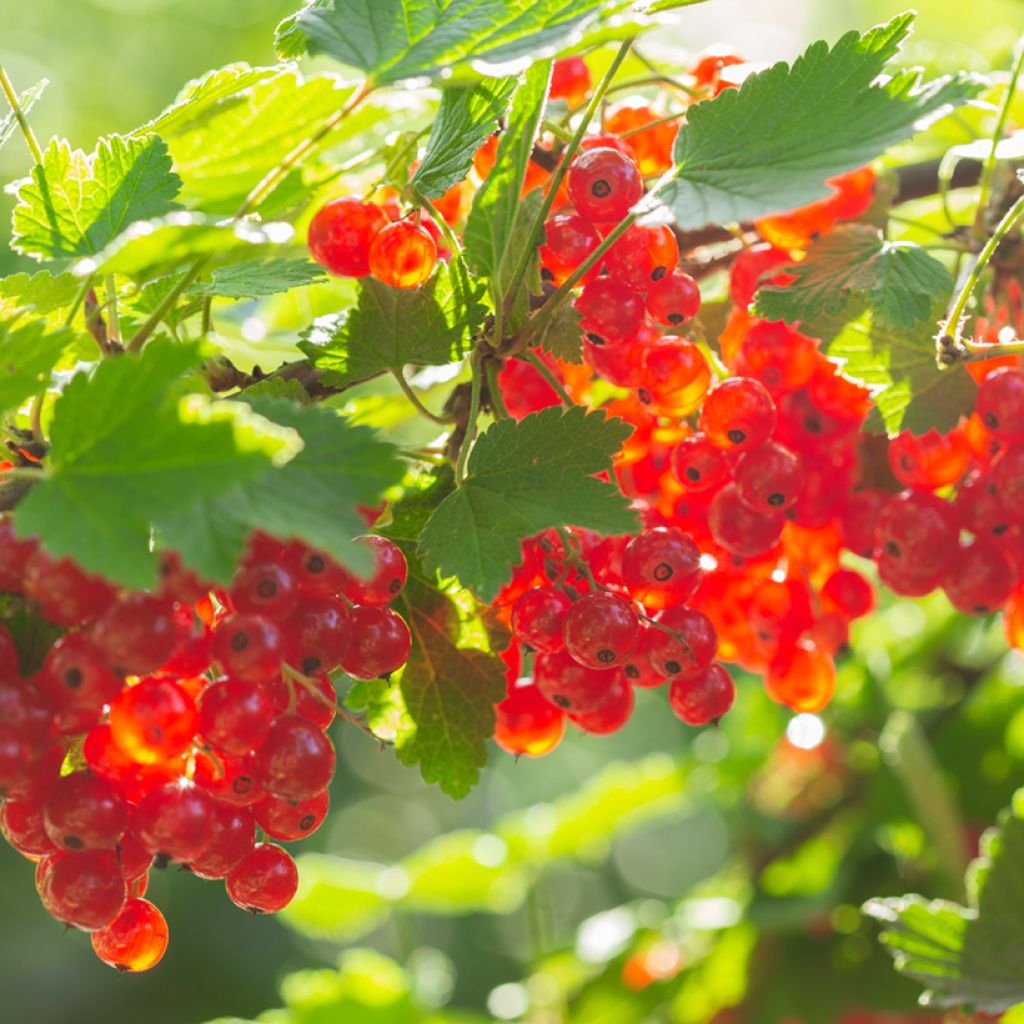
top-left (623, 526), bottom-right (703, 611)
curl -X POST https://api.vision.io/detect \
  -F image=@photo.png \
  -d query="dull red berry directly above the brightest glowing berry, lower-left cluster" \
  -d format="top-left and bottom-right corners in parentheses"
top-left (89, 591), bottom-right (178, 676)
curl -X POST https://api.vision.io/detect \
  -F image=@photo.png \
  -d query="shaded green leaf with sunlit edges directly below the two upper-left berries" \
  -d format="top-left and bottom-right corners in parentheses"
top-left (300, 258), bottom-right (485, 387)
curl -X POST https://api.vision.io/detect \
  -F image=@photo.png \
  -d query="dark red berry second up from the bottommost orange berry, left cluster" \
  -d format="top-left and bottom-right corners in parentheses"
top-left (43, 771), bottom-right (128, 850)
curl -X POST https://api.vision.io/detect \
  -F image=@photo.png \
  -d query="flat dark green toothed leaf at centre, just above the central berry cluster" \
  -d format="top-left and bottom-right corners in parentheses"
top-left (419, 407), bottom-right (636, 601)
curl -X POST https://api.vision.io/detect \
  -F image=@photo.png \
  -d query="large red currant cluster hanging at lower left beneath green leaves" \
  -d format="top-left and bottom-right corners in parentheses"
top-left (0, 519), bottom-right (410, 971)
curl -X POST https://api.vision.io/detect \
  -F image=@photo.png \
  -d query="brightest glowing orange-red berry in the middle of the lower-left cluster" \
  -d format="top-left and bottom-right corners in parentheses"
top-left (111, 678), bottom-right (199, 764)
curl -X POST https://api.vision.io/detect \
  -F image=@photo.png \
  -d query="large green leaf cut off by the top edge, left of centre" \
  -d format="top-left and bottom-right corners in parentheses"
top-left (276, 0), bottom-right (606, 84)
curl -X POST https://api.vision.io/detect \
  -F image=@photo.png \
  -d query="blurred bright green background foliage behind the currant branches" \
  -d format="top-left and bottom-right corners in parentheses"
top-left (0, 0), bottom-right (1024, 1024)
